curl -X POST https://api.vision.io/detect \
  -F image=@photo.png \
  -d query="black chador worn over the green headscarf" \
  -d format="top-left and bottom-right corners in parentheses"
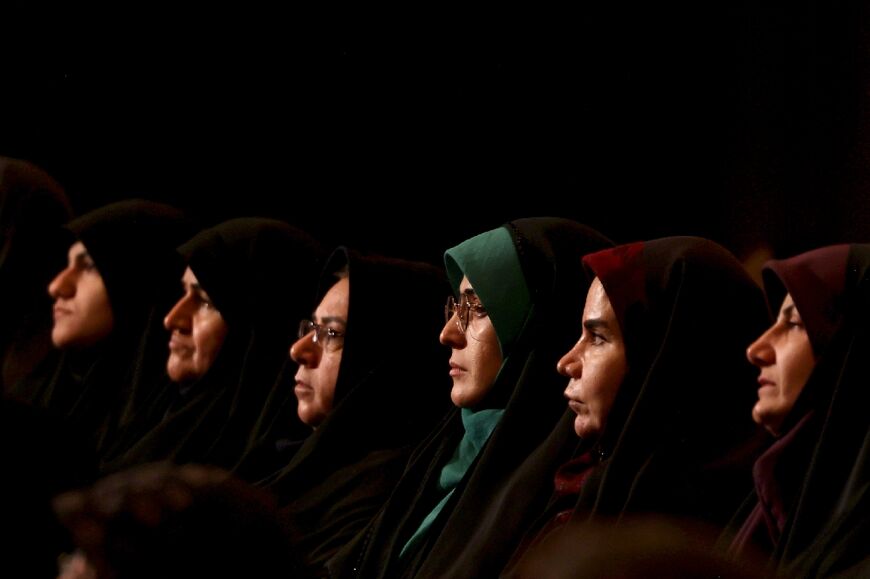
top-left (330, 217), bottom-right (612, 577)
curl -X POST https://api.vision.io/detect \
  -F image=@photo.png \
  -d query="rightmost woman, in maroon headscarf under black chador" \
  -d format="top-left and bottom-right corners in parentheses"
top-left (727, 245), bottom-right (870, 577)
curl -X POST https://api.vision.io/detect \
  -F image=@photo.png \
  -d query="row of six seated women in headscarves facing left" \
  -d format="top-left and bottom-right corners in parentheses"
top-left (7, 188), bottom-right (870, 578)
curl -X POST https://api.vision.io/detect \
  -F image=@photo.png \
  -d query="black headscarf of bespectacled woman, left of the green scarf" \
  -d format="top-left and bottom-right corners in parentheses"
top-left (262, 248), bottom-right (450, 576)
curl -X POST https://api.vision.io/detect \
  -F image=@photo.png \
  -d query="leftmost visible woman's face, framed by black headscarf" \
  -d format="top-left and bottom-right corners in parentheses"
top-left (48, 241), bottom-right (115, 348)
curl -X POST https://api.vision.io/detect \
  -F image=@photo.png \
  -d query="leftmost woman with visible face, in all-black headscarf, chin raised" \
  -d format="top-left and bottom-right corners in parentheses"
top-left (13, 200), bottom-right (190, 452)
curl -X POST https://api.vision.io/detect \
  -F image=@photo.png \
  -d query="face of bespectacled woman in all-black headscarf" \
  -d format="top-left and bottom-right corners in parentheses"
top-left (290, 278), bottom-right (350, 428)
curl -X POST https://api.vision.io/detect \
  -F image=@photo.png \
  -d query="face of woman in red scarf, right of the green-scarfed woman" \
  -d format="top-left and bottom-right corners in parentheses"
top-left (556, 277), bottom-right (628, 441)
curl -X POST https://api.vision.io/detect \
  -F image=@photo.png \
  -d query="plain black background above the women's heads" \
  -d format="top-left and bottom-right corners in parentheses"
top-left (0, 0), bottom-right (870, 261)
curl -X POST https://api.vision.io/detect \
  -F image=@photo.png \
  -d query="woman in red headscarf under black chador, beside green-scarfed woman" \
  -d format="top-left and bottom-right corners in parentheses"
top-left (505, 237), bottom-right (768, 576)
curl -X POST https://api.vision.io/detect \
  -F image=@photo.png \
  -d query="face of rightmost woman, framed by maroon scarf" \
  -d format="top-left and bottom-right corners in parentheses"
top-left (746, 294), bottom-right (816, 435)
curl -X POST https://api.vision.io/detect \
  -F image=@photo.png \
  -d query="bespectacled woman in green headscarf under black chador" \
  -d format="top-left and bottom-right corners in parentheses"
top-left (330, 218), bottom-right (612, 577)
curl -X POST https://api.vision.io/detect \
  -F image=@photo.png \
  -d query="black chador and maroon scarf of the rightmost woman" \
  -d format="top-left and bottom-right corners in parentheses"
top-left (731, 244), bottom-right (870, 577)
